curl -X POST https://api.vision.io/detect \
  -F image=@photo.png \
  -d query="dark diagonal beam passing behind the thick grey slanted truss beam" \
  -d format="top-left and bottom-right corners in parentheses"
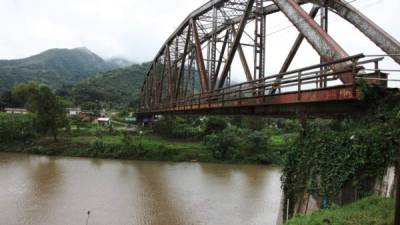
top-left (269, 6), bottom-right (320, 94)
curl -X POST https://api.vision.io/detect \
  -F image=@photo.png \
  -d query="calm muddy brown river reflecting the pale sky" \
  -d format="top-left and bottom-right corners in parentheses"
top-left (0, 153), bottom-right (281, 225)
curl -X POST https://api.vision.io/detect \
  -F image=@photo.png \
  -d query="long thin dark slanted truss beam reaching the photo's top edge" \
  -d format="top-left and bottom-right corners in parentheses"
top-left (217, 0), bottom-right (255, 88)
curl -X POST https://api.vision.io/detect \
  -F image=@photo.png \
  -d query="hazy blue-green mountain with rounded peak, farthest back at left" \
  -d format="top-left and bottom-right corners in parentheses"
top-left (0, 48), bottom-right (127, 93)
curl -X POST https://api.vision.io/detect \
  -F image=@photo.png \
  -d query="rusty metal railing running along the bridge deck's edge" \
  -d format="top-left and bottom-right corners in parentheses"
top-left (141, 54), bottom-right (383, 112)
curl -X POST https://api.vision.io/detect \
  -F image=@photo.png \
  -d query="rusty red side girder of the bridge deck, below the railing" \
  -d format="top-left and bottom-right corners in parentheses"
top-left (138, 85), bottom-right (362, 116)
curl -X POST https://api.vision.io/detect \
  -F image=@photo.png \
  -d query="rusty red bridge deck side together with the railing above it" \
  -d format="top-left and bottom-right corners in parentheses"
top-left (137, 55), bottom-right (386, 117)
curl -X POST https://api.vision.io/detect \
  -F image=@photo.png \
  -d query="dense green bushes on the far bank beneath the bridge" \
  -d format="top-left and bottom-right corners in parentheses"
top-left (154, 116), bottom-right (299, 163)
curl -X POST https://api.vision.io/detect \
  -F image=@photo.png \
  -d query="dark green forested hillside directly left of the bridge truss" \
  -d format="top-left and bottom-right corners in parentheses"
top-left (71, 63), bottom-right (150, 108)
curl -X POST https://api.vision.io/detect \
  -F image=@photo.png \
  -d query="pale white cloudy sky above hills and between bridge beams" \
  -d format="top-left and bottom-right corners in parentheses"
top-left (0, 0), bottom-right (400, 85)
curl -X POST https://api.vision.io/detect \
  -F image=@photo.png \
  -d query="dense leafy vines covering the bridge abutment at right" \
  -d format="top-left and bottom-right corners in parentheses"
top-left (282, 86), bottom-right (400, 218)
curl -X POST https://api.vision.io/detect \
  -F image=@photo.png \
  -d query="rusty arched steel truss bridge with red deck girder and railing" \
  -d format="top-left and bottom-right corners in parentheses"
top-left (138, 0), bottom-right (400, 117)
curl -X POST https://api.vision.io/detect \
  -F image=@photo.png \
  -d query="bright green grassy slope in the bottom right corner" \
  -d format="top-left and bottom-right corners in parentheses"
top-left (285, 196), bottom-right (394, 225)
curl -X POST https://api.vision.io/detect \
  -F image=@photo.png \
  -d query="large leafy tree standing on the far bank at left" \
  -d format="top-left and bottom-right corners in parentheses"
top-left (12, 82), bottom-right (67, 141)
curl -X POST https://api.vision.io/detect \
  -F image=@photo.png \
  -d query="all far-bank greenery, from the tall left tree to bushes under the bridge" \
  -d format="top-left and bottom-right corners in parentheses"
top-left (1, 87), bottom-right (292, 163)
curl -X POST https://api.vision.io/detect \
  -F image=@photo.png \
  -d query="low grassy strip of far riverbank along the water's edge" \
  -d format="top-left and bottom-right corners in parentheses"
top-left (0, 133), bottom-right (288, 164)
